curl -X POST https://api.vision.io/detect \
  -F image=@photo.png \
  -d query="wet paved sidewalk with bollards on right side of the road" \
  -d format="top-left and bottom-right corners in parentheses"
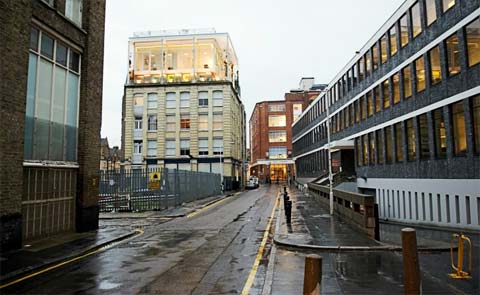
top-left (266, 188), bottom-right (479, 294)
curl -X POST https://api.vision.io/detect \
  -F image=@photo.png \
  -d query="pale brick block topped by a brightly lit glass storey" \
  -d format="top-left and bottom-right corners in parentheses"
top-left (122, 29), bottom-right (246, 189)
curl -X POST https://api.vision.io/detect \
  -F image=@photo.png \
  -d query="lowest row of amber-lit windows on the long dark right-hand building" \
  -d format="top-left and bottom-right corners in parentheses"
top-left (355, 96), bottom-right (480, 166)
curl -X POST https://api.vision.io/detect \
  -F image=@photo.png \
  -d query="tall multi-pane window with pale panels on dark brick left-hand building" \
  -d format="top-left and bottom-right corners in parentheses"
top-left (24, 28), bottom-right (80, 161)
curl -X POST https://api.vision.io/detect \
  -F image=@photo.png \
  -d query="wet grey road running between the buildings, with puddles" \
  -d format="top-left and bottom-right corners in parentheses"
top-left (5, 186), bottom-right (278, 294)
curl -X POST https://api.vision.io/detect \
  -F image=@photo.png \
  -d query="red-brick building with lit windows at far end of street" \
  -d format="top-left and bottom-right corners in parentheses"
top-left (249, 78), bottom-right (320, 183)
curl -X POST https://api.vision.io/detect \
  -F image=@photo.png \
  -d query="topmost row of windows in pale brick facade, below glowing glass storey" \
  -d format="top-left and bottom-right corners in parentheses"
top-left (133, 90), bottom-right (223, 109)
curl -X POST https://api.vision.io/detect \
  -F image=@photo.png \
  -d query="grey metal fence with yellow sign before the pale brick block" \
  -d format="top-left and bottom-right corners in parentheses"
top-left (99, 168), bottom-right (221, 212)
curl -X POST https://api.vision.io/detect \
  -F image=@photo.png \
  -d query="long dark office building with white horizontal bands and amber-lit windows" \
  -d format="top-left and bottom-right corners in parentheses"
top-left (293, 0), bottom-right (480, 230)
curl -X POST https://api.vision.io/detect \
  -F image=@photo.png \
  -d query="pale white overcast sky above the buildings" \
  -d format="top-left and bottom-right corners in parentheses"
top-left (102, 0), bottom-right (404, 146)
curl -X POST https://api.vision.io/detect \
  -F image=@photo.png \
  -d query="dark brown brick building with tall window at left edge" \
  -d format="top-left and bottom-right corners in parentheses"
top-left (0, 0), bottom-right (105, 250)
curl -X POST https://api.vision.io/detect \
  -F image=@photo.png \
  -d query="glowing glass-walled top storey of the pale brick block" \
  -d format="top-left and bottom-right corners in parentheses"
top-left (127, 29), bottom-right (238, 88)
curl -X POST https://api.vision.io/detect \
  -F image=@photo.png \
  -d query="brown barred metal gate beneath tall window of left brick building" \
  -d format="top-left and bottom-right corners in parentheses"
top-left (22, 167), bottom-right (77, 241)
